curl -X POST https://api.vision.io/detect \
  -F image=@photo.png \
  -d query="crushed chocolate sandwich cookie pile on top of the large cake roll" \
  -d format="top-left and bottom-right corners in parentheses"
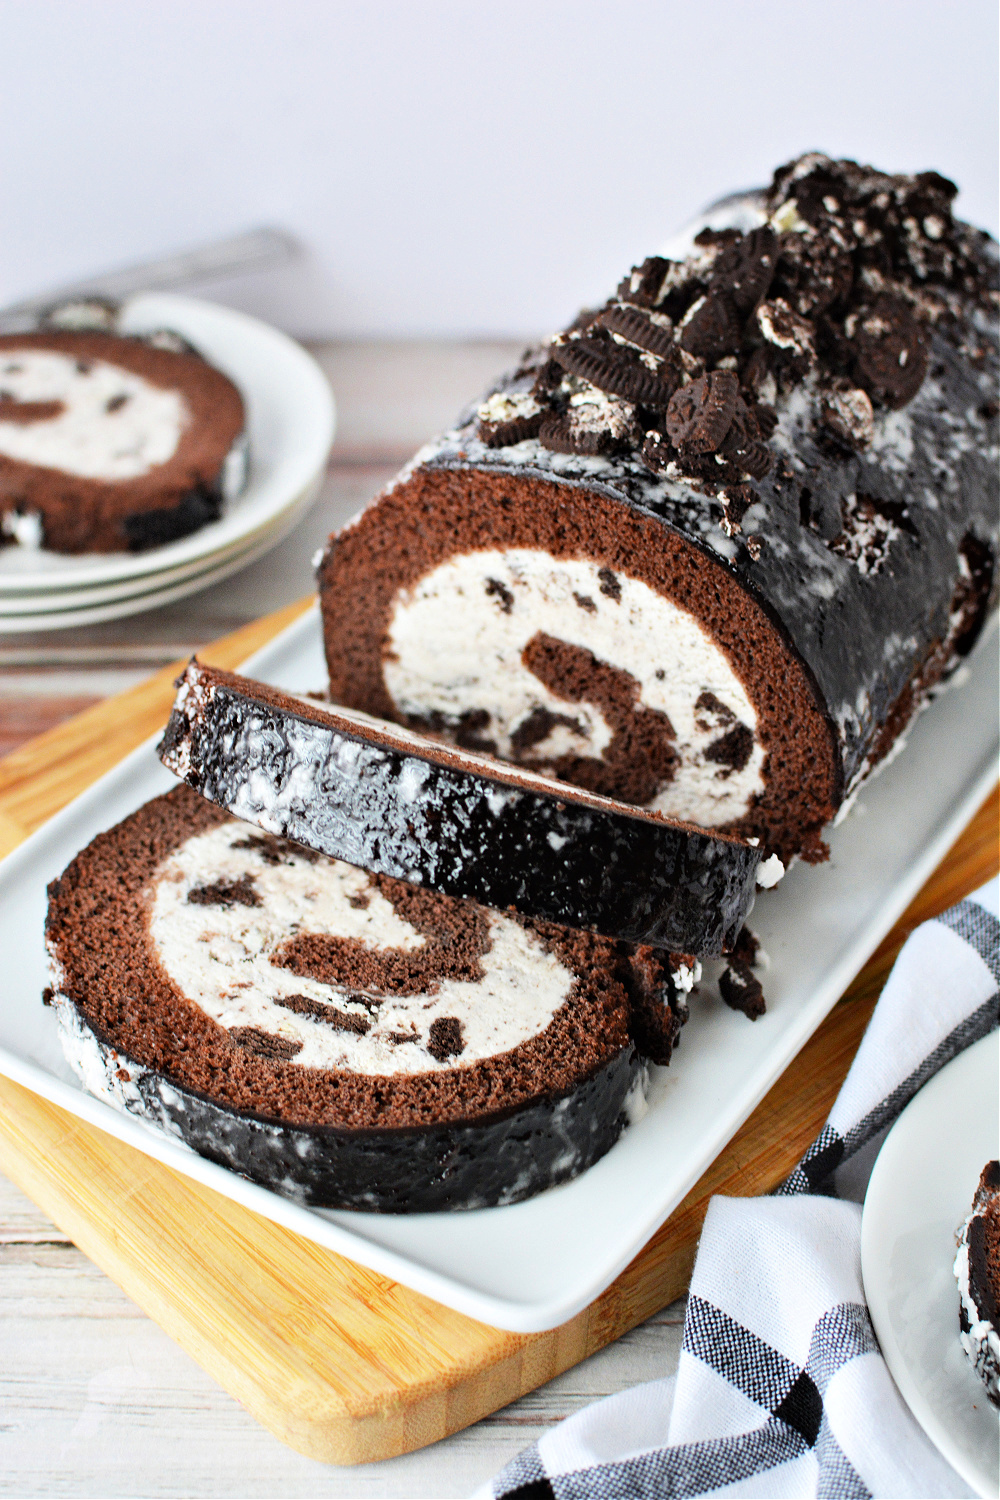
top-left (478, 153), bottom-right (988, 555)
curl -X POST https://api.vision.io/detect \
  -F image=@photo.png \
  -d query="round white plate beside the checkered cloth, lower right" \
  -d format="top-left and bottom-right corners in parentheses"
top-left (861, 1032), bottom-right (1000, 1496)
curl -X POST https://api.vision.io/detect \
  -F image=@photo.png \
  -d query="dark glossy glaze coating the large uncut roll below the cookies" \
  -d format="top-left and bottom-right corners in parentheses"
top-left (410, 301), bottom-right (1000, 788)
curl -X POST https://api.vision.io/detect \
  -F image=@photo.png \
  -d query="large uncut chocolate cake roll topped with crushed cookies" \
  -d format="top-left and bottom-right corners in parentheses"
top-left (319, 155), bottom-right (999, 860)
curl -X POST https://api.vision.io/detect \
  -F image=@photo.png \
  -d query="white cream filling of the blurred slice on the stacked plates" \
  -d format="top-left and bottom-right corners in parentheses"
top-left (0, 350), bottom-right (190, 482)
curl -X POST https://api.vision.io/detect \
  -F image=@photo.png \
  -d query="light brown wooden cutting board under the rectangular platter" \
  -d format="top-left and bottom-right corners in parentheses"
top-left (0, 600), bottom-right (999, 1464)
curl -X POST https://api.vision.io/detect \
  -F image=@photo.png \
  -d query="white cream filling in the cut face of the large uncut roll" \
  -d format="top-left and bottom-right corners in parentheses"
top-left (384, 548), bottom-right (765, 828)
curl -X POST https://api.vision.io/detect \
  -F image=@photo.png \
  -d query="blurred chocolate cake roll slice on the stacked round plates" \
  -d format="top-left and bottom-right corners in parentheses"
top-left (0, 329), bottom-right (246, 552)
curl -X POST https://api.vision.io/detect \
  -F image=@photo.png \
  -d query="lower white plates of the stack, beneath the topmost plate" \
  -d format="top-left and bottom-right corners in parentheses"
top-left (0, 474), bottom-right (322, 635)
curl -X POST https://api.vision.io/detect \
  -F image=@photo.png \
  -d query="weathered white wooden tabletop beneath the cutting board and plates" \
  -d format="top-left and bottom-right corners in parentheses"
top-left (0, 344), bottom-right (684, 1497)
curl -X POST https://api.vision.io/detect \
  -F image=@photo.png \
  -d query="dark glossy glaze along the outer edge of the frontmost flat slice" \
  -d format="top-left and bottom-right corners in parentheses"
top-left (54, 995), bottom-right (643, 1214)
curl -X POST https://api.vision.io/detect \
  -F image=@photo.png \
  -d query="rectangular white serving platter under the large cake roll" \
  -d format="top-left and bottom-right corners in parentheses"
top-left (0, 611), bottom-right (997, 1332)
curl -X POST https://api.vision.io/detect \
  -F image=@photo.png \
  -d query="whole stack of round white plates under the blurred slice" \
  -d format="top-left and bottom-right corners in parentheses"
top-left (0, 293), bottom-right (334, 635)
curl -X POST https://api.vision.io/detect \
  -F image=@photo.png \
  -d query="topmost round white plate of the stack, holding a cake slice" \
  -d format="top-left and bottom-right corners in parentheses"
top-left (0, 293), bottom-right (334, 594)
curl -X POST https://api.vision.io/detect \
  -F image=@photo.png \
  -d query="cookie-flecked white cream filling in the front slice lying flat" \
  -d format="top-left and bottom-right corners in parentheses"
top-left (150, 822), bottom-right (574, 1074)
